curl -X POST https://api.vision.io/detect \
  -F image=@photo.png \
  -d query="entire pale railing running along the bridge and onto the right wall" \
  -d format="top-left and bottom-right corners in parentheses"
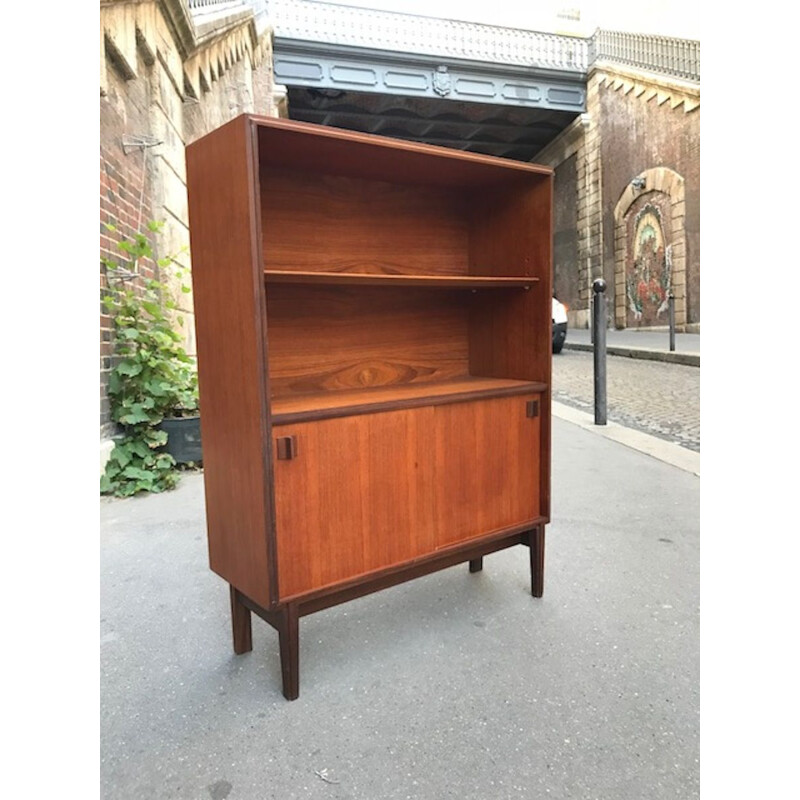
top-left (187, 0), bottom-right (700, 81)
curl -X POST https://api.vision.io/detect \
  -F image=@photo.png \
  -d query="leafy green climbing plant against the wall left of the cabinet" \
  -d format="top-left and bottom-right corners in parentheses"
top-left (100, 222), bottom-right (198, 497)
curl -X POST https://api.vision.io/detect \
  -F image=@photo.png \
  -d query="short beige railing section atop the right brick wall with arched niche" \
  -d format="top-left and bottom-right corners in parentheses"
top-left (591, 30), bottom-right (700, 81)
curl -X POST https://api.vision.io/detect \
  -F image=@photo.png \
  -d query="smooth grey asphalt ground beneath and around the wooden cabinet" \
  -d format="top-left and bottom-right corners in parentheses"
top-left (101, 418), bottom-right (700, 800)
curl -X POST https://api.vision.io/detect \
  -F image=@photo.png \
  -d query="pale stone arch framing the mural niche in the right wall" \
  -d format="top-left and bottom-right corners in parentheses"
top-left (614, 167), bottom-right (686, 329)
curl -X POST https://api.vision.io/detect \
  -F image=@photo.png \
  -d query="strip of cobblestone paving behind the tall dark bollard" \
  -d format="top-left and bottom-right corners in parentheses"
top-left (553, 349), bottom-right (700, 452)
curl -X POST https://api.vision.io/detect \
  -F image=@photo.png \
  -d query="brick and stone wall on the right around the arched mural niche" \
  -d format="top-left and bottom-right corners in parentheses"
top-left (535, 64), bottom-right (700, 330)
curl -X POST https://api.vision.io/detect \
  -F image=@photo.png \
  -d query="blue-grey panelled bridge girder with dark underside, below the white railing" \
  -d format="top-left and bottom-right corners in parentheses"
top-left (274, 40), bottom-right (586, 161)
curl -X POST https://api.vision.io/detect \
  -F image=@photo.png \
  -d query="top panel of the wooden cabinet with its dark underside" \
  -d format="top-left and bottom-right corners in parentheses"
top-left (247, 115), bottom-right (553, 187)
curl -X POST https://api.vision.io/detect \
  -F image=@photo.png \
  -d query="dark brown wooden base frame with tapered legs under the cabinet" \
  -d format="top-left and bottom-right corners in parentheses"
top-left (230, 523), bottom-right (545, 700)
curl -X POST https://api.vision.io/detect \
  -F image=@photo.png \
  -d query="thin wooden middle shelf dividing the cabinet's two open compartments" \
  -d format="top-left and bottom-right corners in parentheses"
top-left (264, 269), bottom-right (539, 289)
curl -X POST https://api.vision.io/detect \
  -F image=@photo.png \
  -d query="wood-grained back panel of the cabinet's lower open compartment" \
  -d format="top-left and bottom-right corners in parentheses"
top-left (267, 285), bottom-right (469, 395)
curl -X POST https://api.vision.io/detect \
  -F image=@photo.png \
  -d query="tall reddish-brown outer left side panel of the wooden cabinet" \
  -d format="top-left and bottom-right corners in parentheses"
top-left (186, 117), bottom-right (270, 606)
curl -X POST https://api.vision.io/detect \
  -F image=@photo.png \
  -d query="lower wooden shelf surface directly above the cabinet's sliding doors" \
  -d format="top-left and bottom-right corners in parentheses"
top-left (272, 375), bottom-right (547, 425)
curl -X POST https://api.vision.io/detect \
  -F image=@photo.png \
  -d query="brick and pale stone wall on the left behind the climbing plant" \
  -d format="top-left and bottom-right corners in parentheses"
top-left (100, 0), bottom-right (285, 446)
